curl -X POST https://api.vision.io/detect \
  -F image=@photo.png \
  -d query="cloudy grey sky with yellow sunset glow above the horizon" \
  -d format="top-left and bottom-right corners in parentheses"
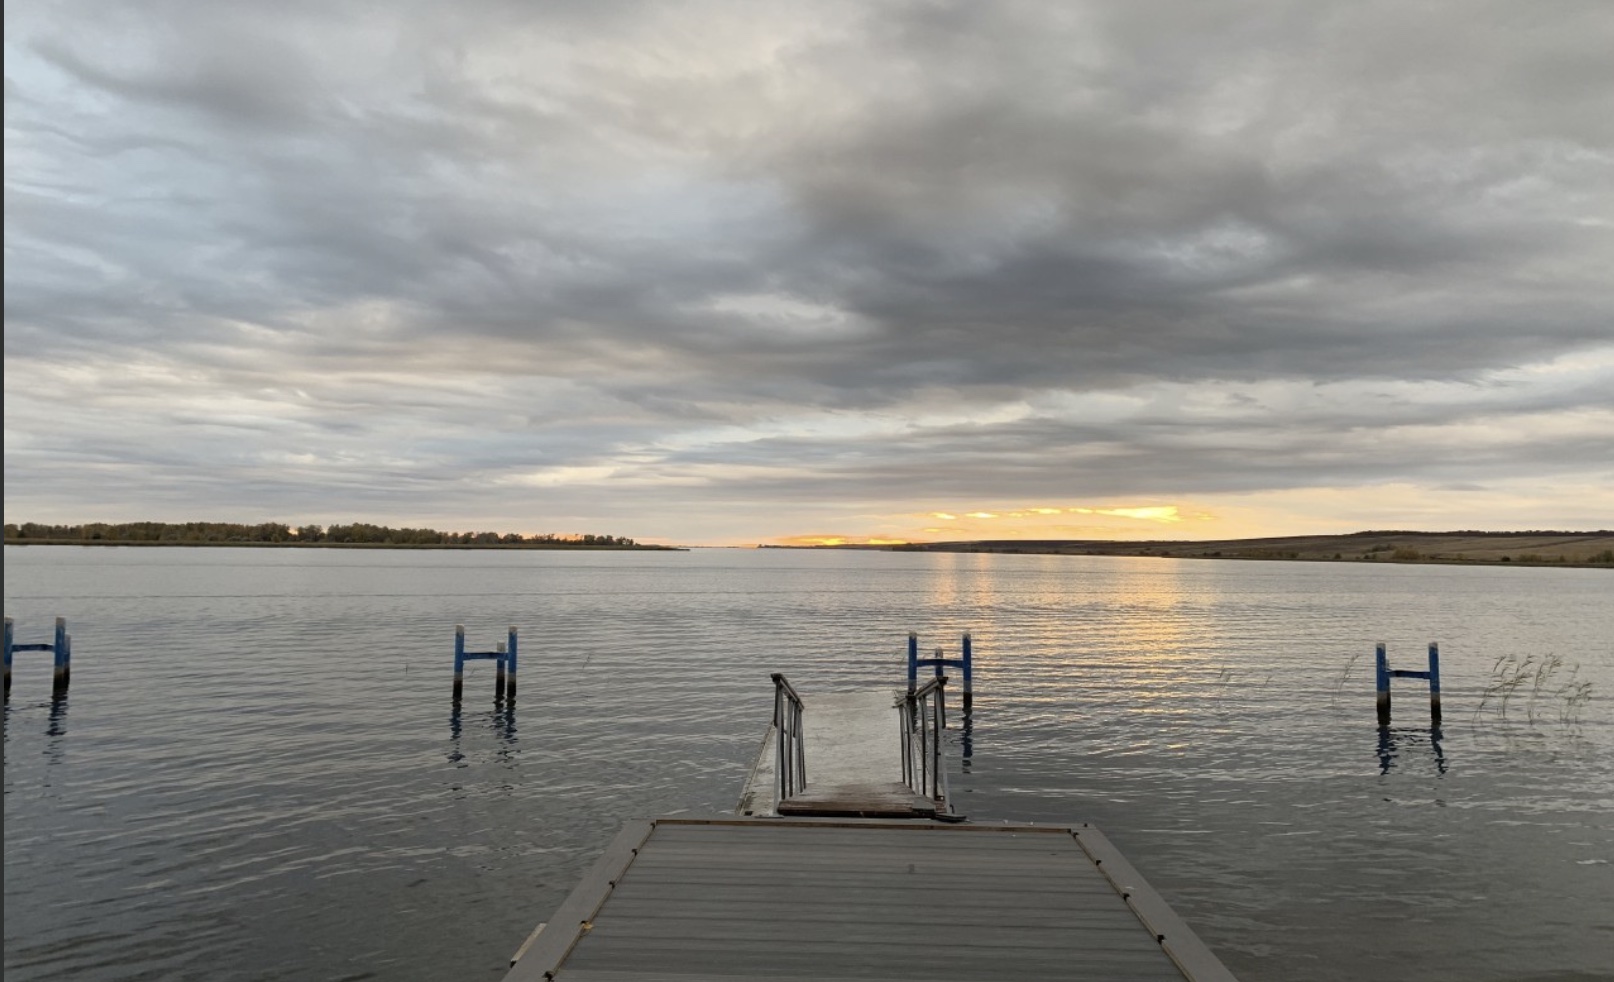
top-left (5, 0), bottom-right (1614, 544)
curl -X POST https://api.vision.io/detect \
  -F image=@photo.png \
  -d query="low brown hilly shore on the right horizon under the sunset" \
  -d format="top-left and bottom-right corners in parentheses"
top-left (765, 530), bottom-right (1614, 569)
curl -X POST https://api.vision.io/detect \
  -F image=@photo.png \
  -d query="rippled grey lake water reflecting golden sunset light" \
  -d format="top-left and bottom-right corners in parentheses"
top-left (5, 548), bottom-right (1614, 982)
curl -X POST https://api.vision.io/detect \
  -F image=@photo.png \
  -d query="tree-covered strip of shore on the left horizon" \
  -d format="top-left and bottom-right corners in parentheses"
top-left (5, 522), bottom-right (681, 552)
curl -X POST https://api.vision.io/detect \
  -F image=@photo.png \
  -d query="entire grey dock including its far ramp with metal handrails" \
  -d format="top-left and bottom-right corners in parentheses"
top-left (505, 639), bottom-right (1235, 982)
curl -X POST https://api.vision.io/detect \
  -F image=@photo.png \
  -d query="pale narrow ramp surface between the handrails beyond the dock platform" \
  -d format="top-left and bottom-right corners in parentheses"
top-left (734, 688), bottom-right (936, 819)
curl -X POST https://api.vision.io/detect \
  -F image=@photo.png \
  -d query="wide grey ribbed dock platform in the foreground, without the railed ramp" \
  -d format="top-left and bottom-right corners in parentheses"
top-left (507, 819), bottom-right (1233, 982)
